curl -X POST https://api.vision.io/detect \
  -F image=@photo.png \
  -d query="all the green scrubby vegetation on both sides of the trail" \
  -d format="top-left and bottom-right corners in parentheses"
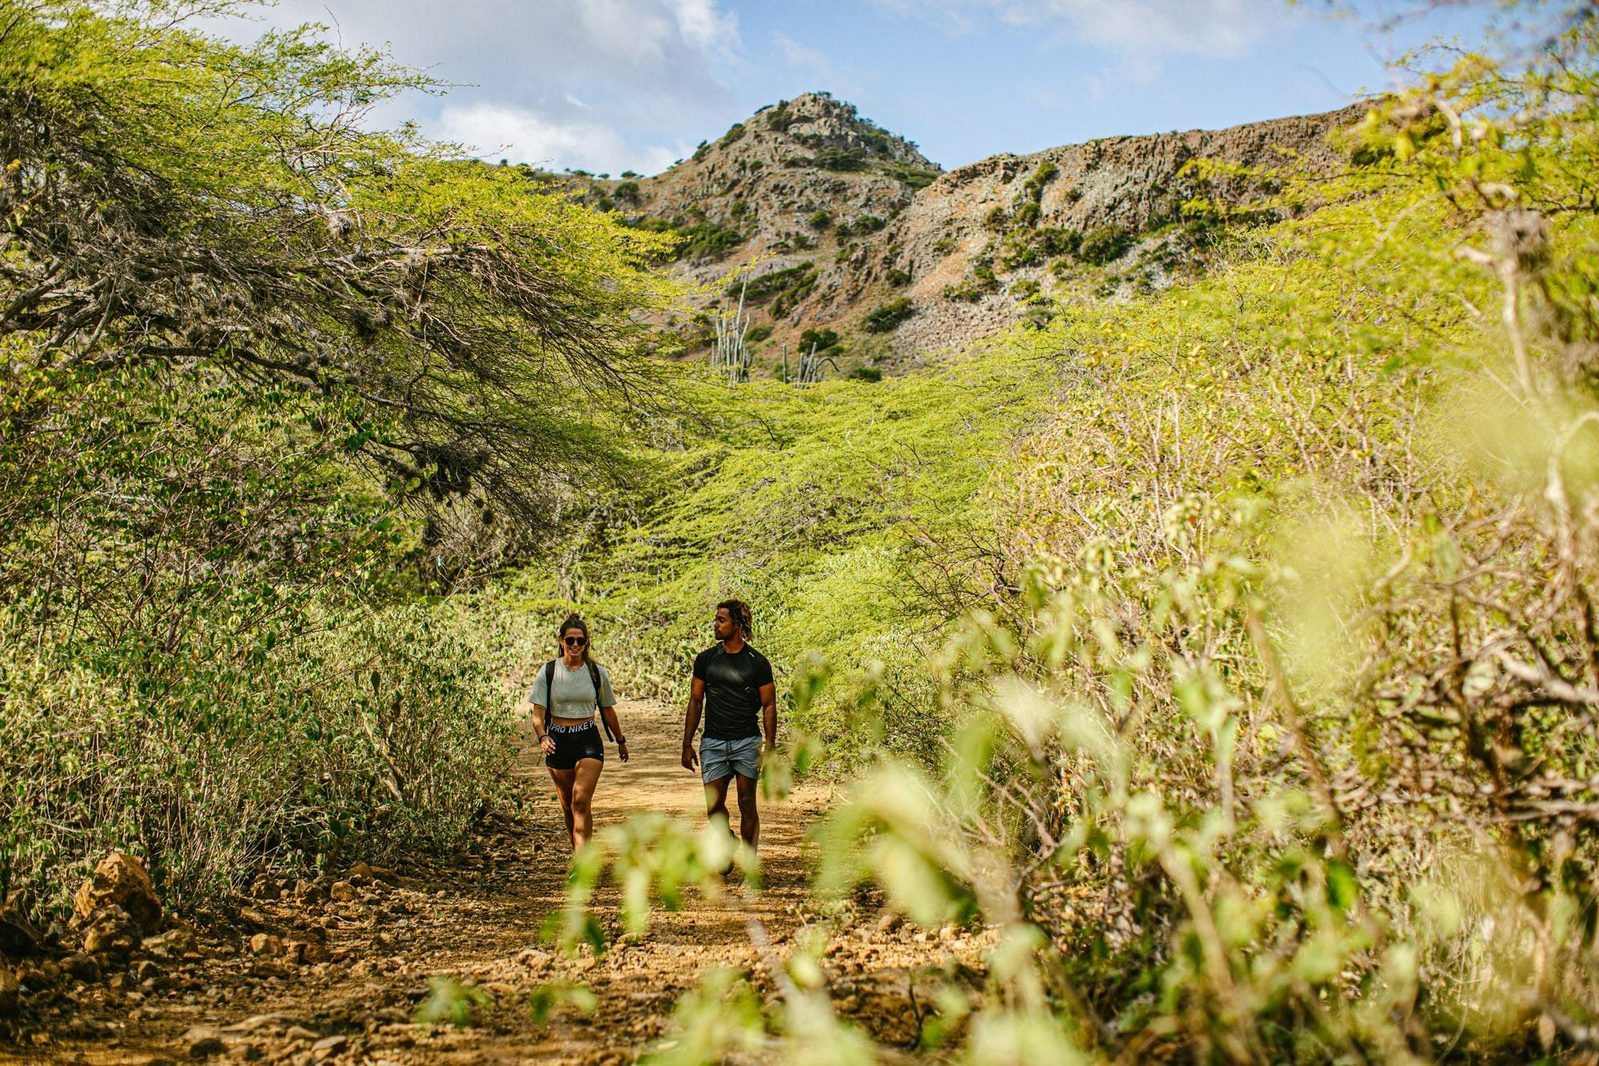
top-left (15, 3), bottom-right (1599, 1063)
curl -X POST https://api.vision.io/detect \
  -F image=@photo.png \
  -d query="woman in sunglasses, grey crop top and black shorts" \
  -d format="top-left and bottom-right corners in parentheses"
top-left (528, 614), bottom-right (627, 852)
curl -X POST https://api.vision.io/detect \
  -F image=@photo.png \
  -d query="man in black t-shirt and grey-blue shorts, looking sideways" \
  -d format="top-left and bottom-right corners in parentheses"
top-left (683, 599), bottom-right (777, 849)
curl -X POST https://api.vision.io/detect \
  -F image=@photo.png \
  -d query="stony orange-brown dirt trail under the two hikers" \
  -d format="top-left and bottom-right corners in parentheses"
top-left (18, 702), bottom-right (823, 1064)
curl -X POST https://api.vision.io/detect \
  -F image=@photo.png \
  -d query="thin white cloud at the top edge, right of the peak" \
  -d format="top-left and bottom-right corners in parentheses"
top-left (876, 0), bottom-right (1287, 56)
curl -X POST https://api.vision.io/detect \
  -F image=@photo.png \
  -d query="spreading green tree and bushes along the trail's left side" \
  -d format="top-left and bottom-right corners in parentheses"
top-left (0, 3), bottom-right (668, 917)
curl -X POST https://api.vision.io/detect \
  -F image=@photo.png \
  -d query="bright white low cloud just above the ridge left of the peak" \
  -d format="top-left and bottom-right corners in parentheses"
top-left (438, 102), bottom-right (683, 174)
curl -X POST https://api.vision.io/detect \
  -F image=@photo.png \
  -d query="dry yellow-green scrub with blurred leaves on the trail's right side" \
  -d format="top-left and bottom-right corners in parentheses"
top-left (546, 11), bottom-right (1599, 1061)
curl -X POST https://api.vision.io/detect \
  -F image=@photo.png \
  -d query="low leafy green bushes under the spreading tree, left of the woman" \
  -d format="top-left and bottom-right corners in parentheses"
top-left (0, 606), bottom-right (512, 913)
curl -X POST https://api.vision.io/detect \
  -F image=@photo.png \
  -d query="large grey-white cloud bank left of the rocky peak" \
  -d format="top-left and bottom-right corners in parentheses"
top-left (201, 0), bottom-right (742, 173)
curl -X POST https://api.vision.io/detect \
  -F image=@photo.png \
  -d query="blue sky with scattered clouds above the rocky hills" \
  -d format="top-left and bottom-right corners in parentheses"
top-left (214, 0), bottom-right (1481, 174)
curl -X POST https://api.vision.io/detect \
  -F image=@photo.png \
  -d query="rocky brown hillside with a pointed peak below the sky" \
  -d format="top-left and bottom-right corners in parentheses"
top-left (559, 93), bottom-right (1359, 372)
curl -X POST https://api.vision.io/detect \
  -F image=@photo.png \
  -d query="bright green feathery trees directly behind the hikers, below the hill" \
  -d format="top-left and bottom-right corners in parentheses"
top-left (504, 331), bottom-right (1046, 757)
